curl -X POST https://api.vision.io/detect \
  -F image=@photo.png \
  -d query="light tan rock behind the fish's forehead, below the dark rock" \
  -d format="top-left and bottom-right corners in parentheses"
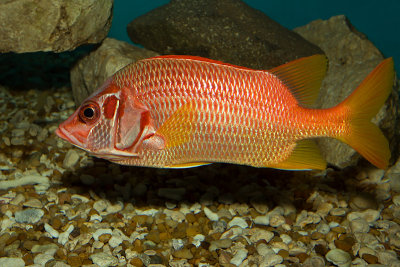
top-left (71, 38), bottom-right (158, 106)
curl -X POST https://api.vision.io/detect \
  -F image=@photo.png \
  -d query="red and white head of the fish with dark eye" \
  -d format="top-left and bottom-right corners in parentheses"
top-left (56, 79), bottom-right (160, 162)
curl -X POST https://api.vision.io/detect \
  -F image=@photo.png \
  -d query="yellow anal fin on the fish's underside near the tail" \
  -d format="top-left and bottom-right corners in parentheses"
top-left (266, 139), bottom-right (326, 170)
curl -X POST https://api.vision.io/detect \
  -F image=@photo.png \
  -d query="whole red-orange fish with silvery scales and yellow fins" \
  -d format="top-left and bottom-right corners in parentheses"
top-left (56, 55), bottom-right (394, 170)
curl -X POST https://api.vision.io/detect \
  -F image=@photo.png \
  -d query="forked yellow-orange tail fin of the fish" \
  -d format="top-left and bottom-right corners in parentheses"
top-left (338, 58), bottom-right (394, 169)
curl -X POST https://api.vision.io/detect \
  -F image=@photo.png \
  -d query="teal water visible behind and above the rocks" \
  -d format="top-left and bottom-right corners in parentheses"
top-left (109, 0), bottom-right (400, 71)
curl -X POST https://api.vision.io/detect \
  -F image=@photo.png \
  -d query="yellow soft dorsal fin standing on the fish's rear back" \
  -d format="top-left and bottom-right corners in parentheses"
top-left (269, 55), bottom-right (328, 105)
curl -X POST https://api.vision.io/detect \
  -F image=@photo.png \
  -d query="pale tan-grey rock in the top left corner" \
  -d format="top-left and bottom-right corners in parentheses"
top-left (0, 0), bottom-right (113, 53)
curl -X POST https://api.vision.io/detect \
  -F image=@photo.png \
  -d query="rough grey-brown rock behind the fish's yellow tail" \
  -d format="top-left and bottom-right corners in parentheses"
top-left (294, 15), bottom-right (399, 168)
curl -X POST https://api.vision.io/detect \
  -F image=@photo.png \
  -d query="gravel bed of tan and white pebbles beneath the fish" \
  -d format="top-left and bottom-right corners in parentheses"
top-left (0, 87), bottom-right (400, 266)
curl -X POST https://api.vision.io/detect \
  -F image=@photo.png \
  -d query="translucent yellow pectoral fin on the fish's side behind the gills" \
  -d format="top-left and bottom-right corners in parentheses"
top-left (156, 103), bottom-right (196, 148)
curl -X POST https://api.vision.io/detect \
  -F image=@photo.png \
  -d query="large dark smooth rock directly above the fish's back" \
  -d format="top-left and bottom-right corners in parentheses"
top-left (127, 0), bottom-right (323, 69)
